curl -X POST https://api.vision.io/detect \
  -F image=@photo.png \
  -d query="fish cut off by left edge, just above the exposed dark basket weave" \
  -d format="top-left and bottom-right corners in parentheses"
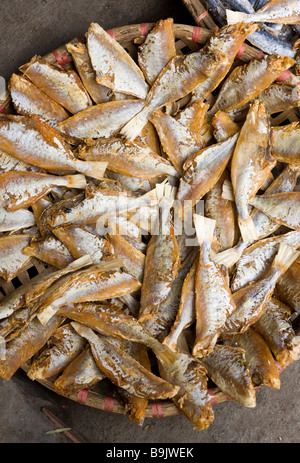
top-left (0, 234), bottom-right (32, 281)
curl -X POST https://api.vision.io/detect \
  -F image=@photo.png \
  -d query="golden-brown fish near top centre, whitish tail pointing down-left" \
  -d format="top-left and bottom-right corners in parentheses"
top-left (120, 34), bottom-right (228, 140)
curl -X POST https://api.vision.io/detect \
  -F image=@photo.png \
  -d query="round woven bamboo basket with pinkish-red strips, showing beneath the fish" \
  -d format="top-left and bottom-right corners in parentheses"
top-left (0, 20), bottom-right (300, 418)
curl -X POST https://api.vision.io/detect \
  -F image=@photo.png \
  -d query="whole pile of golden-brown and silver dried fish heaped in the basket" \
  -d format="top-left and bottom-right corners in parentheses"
top-left (0, 12), bottom-right (300, 430)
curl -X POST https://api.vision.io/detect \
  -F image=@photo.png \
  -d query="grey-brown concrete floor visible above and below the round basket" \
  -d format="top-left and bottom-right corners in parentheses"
top-left (0, 0), bottom-right (300, 444)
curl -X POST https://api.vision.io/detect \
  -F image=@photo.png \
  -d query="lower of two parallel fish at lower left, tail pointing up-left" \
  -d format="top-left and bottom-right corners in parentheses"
top-left (71, 322), bottom-right (178, 399)
